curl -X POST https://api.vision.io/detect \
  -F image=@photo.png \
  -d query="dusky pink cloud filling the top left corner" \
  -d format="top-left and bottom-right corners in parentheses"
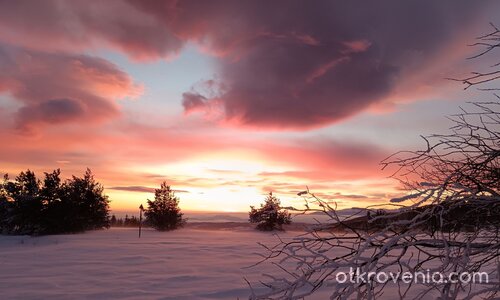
top-left (0, 0), bottom-right (184, 60)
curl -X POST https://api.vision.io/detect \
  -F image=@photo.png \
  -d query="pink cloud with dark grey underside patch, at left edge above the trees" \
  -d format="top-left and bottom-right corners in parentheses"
top-left (0, 44), bottom-right (138, 130)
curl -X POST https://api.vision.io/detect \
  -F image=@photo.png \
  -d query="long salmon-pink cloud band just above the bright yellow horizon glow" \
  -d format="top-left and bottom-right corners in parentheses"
top-left (0, 116), bottom-right (390, 185)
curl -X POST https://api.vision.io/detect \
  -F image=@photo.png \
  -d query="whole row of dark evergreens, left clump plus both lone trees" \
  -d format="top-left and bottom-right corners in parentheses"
top-left (0, 169), bottom-right (291, 235)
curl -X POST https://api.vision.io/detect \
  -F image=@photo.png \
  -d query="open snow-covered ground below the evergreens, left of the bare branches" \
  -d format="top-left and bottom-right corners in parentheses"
top-left (0, 226), bottom-right (322, 299)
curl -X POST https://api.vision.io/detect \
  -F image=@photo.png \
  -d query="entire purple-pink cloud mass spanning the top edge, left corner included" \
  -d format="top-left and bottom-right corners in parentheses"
top-left (0, 0), bottom-right (492, 129)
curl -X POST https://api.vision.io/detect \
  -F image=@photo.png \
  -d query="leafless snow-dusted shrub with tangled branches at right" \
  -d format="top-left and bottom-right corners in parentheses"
top-left (250, 27), bottom-right (500, 299)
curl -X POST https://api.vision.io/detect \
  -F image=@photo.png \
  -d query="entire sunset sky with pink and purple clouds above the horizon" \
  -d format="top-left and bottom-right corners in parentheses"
top-left (0, 0), bottom-right (500, 212)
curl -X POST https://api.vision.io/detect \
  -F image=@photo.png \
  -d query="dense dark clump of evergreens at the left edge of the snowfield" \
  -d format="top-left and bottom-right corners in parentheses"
top-left (0, 169), bottom-right (110, 235)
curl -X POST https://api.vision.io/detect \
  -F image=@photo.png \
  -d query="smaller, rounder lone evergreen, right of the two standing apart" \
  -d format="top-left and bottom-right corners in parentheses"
top-left (249, 192), bottom-right (292, 231)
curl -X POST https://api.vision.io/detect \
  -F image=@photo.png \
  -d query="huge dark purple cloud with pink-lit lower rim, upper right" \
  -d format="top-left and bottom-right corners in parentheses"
top-left (131, 0), bottom-right (491, 128)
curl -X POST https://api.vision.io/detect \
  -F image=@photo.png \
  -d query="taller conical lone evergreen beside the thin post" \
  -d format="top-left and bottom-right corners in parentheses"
top-left (144, 182), bottom-right (185, 231)
